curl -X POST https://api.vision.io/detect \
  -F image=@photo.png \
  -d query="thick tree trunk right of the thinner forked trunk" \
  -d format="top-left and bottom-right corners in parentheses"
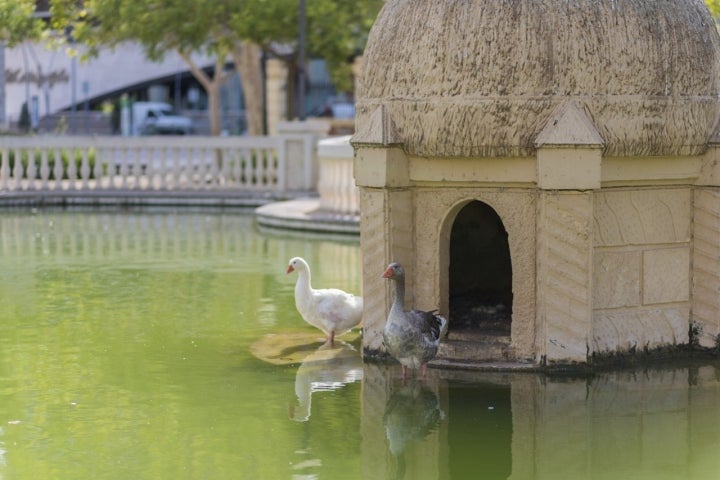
top-left (231, 42), bottom-right (265, 135)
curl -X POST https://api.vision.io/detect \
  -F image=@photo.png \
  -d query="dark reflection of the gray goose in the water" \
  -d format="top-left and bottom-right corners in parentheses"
top-left (383, 380), bottom-right (445, 478)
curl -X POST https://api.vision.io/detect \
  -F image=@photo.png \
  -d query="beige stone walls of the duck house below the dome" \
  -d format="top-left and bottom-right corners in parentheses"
top-left (355, 142), bottom-right (720, 362)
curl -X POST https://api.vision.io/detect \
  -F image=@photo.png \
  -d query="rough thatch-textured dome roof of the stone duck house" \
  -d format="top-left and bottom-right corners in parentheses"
top-left (353, 0), bottom-right (720, 157)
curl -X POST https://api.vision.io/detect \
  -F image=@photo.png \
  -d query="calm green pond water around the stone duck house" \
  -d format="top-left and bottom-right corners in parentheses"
top-left (0, 209), bottom-right (720, 480)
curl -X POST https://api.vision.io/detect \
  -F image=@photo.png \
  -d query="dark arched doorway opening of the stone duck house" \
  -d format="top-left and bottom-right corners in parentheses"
top-left (448, 201), bottom-right (512, 335)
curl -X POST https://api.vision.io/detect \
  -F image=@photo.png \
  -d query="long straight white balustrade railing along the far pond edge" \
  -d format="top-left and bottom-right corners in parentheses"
top-left (0, 134), bottom-right (317, 194)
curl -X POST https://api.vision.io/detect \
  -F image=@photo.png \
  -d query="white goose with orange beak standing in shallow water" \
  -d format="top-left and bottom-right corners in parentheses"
top-left (287, 257), bottom-right (363, 344)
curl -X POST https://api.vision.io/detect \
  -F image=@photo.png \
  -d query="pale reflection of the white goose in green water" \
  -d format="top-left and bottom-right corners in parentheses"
top-left (288, 340), bottom-right (363, 422)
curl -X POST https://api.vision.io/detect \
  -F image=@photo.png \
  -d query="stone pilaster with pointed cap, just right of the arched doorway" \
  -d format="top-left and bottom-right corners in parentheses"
top-left (535, 101), bottom-right (603, 363)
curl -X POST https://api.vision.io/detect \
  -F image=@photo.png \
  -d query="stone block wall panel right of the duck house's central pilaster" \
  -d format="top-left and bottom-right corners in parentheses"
top-left (592, 187), bottom-right (693, 353)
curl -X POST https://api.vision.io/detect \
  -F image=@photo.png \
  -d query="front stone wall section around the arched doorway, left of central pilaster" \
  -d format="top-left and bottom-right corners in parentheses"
top-left (354, 147), bottom-right (537, 358)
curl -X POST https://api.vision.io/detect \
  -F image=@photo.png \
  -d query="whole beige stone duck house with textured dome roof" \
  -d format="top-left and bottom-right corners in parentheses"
top-left (351, 0), bottom-right (720, 365)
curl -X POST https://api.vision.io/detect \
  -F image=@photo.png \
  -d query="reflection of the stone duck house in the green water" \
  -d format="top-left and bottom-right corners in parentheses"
top-left (361, 364), bottom-right (720, 480)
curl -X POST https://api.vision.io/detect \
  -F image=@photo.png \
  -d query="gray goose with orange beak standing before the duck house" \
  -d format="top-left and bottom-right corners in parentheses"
top-left (382, 262), bottom-right (447, 378)
